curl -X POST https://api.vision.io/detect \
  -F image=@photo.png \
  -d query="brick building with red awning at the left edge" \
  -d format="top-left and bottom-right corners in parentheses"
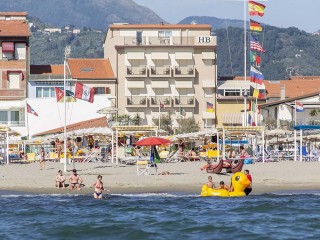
top-left (0, 12), bottom-right (30, 131)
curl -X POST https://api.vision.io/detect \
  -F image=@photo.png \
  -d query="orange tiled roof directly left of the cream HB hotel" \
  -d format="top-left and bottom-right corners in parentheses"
top-left (68, 58), bottom-right (116, 79)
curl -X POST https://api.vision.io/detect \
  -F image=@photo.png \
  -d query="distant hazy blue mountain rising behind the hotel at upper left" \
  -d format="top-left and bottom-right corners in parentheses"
top-left (1, 0), bottom-right (164, 30)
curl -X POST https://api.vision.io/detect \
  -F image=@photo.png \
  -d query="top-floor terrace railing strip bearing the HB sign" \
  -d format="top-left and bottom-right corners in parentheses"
top-left (123, 36), bottom-right (217, 46)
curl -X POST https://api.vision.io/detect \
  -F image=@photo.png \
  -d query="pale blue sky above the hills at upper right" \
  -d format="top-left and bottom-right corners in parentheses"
top-left (134, 0), bottom-right (320, 32)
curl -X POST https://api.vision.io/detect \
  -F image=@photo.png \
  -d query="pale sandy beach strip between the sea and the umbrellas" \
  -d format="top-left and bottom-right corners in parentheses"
top-left (0, 161), bottom-right (320, 194)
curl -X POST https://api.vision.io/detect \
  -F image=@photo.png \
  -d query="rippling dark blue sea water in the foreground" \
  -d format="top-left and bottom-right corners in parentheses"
top-left (0, 192), bottom-right (320, 240)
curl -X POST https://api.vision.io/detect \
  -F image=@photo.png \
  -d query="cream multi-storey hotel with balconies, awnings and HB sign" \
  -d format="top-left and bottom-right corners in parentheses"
top-left (104, 23), bottom-right (217, 129)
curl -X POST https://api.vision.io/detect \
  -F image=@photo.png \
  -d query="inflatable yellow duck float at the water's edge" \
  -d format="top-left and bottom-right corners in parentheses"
top-left (200, 172), bottom-right (250, 197)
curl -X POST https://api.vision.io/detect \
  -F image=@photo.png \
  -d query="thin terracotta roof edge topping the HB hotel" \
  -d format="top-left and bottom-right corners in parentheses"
top-left (109, 24), bottom-right (212, 30)
